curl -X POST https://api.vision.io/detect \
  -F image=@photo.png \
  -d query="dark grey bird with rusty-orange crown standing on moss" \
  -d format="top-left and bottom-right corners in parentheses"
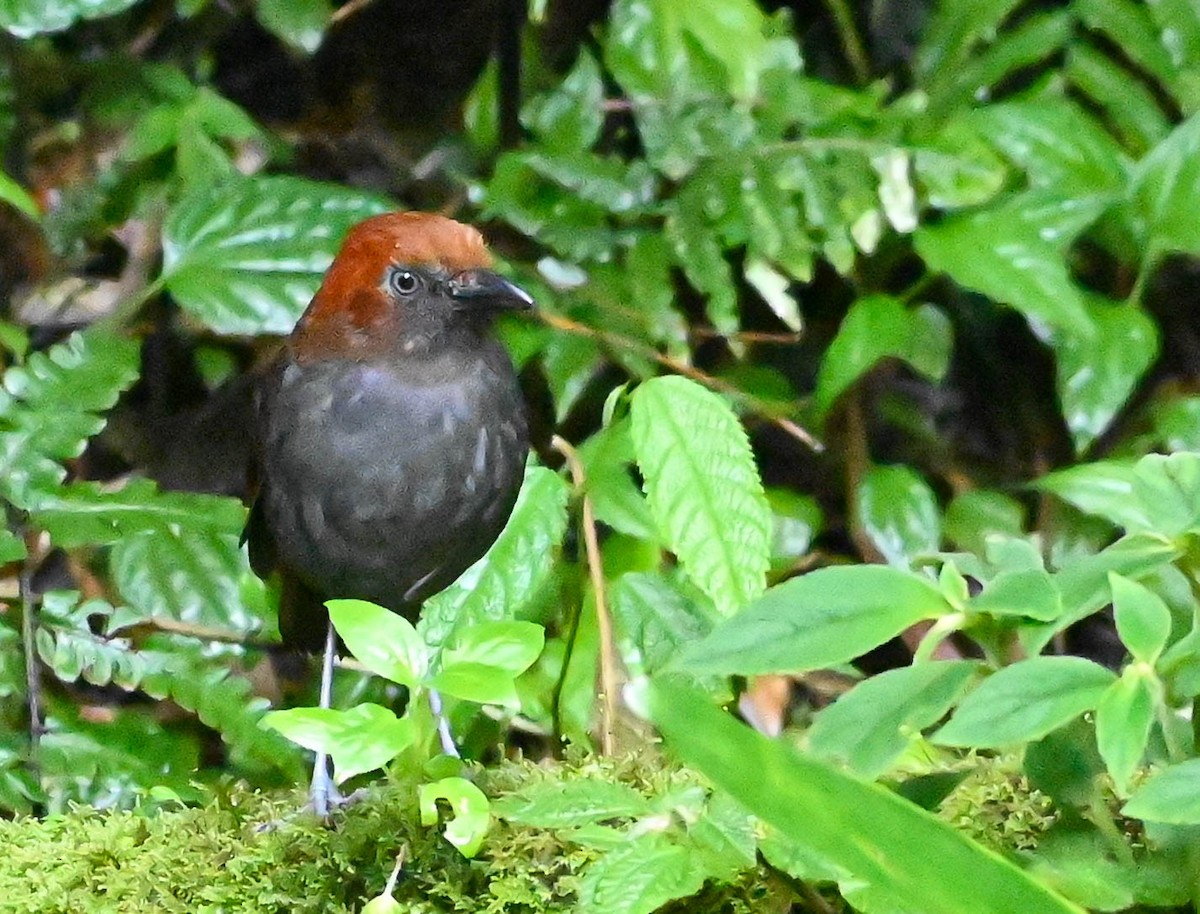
top-left (244, 211), bottom-right (533, 817)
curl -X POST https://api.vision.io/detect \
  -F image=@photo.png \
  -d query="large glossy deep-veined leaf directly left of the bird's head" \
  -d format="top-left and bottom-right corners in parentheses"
top-left (162, 178), bottom-right (394, 335)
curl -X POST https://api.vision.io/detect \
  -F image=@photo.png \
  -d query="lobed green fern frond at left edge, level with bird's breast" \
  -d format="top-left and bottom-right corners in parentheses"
top-left (0, 330), bottom-right (138, 507)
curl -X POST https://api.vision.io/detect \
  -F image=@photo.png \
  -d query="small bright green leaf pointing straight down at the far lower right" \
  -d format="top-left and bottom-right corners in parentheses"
top-left (1096, 665), bottom-right (1163, 796)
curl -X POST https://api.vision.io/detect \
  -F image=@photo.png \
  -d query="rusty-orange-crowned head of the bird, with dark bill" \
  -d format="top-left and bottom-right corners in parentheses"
top-left (292, 212), bottom-right (533, 361)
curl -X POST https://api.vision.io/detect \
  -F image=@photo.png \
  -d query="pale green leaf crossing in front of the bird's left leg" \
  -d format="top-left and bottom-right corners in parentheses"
top-left (262, 702), bottom-right (416, 783)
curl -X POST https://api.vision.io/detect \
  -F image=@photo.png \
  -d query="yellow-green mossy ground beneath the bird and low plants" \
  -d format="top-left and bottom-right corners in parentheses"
top-left (0, 753), bottom-right (1060, 914)
